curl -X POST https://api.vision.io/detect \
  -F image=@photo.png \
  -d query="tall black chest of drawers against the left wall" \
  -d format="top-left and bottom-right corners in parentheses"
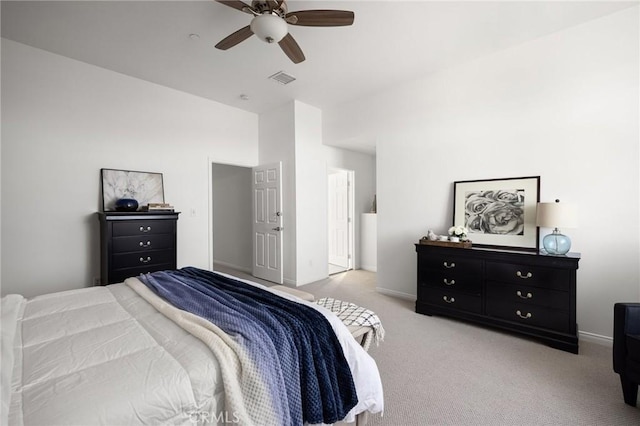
top-left (98, 212), bottom-right (179, 285)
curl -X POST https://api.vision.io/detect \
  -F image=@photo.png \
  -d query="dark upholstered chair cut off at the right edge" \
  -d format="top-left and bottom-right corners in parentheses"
top-left (613, 303), bottom-right (640, 407)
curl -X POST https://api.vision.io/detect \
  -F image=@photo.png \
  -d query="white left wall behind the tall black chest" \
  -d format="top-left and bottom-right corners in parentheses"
top-left (1, 39), bottom-right (258, 296)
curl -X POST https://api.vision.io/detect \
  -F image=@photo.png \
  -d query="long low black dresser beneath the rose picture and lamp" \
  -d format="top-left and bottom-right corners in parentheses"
top-left (416, 244), bottom-right (580, 353)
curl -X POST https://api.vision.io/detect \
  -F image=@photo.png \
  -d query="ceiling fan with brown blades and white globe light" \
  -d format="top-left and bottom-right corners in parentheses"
top-left (216, 0), bottom-right (354, 64)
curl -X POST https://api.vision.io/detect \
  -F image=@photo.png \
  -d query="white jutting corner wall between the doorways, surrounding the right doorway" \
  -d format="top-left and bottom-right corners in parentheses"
top-left (260, 101), bottom-right (375, 286)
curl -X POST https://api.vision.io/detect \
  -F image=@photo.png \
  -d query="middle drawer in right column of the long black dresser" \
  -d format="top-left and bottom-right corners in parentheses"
top-left (486, 281), bottom-right (571, 310)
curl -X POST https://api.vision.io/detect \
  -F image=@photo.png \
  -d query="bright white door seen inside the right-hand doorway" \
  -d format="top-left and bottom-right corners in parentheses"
top-left (328, 170), bottom-right (350, 269)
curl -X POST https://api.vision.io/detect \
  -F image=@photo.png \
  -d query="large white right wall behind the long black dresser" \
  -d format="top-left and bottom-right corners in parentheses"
top-left (324, 7), bottom-right (640, 336)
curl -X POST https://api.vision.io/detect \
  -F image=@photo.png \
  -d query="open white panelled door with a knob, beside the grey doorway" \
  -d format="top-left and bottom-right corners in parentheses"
top-left (252, 163), bottom-right (283, 284)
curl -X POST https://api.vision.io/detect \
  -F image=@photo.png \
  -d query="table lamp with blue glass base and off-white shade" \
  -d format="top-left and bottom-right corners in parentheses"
top-left (536, 200), bottom-right (577, 254)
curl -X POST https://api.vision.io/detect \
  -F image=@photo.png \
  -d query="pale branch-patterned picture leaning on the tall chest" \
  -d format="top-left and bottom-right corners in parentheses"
top-left (100, 169), bottom-right (164, 212)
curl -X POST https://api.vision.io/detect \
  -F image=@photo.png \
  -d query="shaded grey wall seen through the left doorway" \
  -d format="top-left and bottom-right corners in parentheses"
top-left (211, 163), bottom-right (253, 273)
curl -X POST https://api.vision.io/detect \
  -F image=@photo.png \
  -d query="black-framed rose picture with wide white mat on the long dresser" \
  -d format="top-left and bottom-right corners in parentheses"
top-left (453, 176), bottom-right (540, 251)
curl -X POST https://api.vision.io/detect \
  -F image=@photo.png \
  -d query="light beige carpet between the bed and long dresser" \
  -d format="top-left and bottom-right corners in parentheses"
top-left (216, 270), bottom-right (640, 426)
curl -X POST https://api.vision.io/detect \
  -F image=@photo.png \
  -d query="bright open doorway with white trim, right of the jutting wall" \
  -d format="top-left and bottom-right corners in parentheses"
top-left (327, 169), bottom-right (354, 275)
